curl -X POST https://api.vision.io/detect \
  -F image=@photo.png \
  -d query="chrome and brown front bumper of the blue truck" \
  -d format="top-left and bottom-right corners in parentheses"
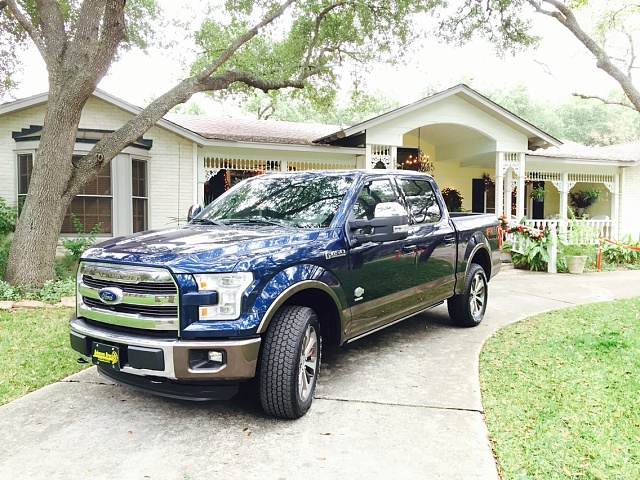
top-left (69, 316), bottom-right (260, 388)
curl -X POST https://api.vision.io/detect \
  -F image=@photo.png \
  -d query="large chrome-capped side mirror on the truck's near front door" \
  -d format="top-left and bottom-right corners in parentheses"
top-left (348, 202), bottom-right (409, 244)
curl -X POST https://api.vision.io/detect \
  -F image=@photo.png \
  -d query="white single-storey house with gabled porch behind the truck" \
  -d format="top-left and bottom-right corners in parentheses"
top-left (0, 85), bottom-right (640, 244)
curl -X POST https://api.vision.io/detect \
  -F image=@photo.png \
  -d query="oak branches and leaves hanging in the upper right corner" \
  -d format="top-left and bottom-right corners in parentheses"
top-left (442, 0), bottom-right (640, 112)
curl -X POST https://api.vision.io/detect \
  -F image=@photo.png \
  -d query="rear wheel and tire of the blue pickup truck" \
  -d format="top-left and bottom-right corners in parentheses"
top-left (447, 263), bottom-right (489, 327)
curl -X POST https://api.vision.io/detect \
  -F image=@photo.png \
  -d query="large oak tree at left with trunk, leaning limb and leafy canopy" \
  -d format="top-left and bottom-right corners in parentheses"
top-left (0, 0), bottom-right (440, 285)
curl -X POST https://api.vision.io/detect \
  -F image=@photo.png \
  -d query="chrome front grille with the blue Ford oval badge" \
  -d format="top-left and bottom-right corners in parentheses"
top-left (78, 262), bottom-right (179, 331)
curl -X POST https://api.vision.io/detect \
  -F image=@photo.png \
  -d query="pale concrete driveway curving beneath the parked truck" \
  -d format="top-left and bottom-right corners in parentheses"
top-left (0, 270), bottom-right (640, 480)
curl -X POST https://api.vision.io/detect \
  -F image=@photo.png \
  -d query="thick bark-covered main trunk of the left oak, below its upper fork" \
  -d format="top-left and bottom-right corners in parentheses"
top-left (5, 92), bottom-right (89, 286)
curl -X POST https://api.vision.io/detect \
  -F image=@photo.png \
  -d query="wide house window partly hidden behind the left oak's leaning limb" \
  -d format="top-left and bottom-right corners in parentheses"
top-left (61, 155), bottom-right (113, 234)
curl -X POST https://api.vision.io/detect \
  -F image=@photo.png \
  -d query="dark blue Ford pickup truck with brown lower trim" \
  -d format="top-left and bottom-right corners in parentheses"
top-left (70, 170), bottom-right (500, 418)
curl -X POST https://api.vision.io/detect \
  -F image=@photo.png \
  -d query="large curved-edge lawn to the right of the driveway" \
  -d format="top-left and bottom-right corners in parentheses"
top-left (480, 297), bottom-right (640, 480)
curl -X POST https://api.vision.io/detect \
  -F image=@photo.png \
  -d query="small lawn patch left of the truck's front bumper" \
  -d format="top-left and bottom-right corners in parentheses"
top-left (0, 308), bottom-right (86, 405)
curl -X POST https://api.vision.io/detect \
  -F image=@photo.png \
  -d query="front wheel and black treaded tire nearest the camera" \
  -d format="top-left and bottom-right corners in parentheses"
top-left (259, 306), bottom-right (322, 419)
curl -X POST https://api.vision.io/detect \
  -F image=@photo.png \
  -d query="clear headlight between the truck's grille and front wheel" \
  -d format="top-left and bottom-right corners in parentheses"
top-left (194, 272), bottom-right (253, 320)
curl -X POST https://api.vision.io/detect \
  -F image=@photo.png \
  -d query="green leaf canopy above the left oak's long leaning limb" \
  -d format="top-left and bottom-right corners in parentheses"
top-left (192, 0), bottom-right (440, 105)
